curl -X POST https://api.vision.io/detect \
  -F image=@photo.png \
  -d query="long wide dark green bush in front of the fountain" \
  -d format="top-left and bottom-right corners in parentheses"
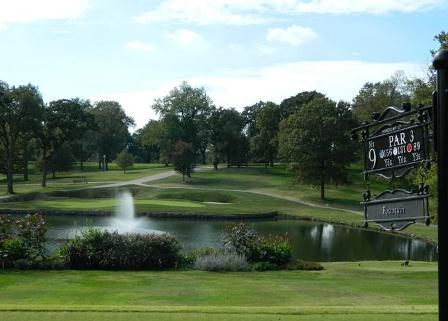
top-left (62, 229), bottom-right (180, 270)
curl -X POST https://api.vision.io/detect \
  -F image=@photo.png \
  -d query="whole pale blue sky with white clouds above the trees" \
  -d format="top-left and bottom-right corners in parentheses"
top-left (0, 0), bottom-right (448, 130)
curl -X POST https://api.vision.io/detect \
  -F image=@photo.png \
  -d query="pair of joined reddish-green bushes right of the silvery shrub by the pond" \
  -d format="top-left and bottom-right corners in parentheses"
top-left (223, 223), bottom-right (292, 266)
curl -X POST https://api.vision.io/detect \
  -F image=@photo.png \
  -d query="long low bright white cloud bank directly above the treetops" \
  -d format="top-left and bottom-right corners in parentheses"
top-left (93, 60), bottom-right (425, 129)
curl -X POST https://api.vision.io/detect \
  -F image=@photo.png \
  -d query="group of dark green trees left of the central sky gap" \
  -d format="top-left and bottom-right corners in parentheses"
top-left (0, 82), bottom-right (134, 194)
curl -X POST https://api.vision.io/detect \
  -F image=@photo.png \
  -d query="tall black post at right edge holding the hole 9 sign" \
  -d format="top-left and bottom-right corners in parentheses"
top-left (433, 50), bottom-right (448, 321)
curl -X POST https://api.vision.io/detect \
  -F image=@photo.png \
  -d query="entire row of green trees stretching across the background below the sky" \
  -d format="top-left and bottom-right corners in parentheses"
top-left (0, 32), bottom-right (448, 199)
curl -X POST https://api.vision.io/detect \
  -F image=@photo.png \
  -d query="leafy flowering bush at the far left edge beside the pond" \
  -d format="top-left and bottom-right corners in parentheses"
top-left (0, 214), bottom-right (46, 268)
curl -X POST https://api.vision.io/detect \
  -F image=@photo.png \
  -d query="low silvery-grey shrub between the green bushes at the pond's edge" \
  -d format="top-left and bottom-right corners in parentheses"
top-left (194, 252), bottom-right (249, 272)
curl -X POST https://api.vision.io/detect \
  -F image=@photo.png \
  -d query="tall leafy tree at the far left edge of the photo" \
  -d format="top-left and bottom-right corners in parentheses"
top-left (0, 81), bottom-right (43, 194)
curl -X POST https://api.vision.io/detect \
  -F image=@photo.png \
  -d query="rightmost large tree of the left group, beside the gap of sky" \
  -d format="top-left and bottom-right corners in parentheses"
top-left (91, 101), bottom-right (135, 170)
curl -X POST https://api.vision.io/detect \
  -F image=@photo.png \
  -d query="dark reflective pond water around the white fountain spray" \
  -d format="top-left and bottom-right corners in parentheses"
top-left (42, 216), bottom-right (437, 262)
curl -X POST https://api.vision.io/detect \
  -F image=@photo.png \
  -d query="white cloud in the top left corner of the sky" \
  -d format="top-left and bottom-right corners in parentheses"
top-left (0, 0), bottom-right (89, 28)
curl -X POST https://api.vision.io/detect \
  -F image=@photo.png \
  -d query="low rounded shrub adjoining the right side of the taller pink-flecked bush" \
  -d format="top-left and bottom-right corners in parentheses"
top-left (246, 235), bottom-right (291, 265)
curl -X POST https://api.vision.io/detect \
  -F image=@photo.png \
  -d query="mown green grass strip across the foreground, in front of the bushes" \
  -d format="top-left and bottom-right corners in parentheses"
top-left (0, 261), bottom-right (437, 320)
